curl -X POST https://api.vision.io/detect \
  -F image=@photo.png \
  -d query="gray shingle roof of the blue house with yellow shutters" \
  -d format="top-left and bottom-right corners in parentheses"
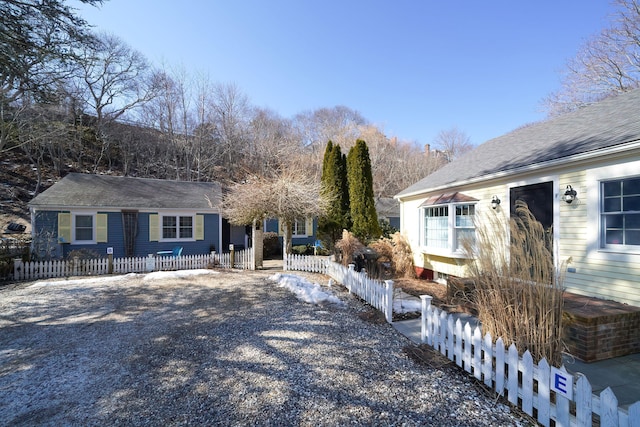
top-left (29, 173), bottom-right (222, 211)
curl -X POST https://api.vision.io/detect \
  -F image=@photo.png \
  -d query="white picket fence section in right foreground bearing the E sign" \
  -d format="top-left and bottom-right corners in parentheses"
top-left (421, 295), bottom-right (640, 427)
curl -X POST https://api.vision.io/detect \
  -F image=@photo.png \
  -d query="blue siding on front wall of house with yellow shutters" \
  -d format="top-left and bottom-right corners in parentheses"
top-left (34, 211), bottom-right (220, 258)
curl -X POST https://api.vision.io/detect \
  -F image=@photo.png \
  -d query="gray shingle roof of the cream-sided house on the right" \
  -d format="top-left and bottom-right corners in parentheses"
top-left (396, 89), bottom-right (640, 197)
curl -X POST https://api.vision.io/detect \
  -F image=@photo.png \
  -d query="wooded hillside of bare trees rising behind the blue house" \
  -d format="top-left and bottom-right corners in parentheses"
top-left (0, 0), bottom-right (464, 237)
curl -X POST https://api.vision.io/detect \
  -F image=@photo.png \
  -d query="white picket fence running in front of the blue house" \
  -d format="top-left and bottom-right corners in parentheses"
top-left (13, 249), bottom-right (255, 280)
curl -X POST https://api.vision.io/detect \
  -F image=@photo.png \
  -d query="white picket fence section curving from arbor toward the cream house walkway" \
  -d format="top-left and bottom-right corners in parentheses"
top-left (282, 254), bottom-right (393, 323)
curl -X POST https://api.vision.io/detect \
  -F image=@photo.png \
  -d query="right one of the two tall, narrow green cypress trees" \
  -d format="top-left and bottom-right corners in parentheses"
top-left (347, 139), bottom-right (381, 240)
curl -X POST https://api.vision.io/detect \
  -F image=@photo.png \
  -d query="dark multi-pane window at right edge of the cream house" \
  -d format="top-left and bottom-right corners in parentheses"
top-left (600, 178), bottom-right (640, 248)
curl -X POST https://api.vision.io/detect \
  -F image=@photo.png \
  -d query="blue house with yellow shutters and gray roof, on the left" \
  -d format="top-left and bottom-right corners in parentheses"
top-left (29, 173), bottom-right (242, 258)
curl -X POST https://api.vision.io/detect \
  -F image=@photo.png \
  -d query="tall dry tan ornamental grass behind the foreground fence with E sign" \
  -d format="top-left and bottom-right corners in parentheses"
top-left (464, 202), bottom-right (564, 366)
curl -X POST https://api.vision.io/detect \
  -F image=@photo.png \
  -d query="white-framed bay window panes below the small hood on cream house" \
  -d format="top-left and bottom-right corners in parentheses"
top-left (422, 204), bottom-right (475, 252)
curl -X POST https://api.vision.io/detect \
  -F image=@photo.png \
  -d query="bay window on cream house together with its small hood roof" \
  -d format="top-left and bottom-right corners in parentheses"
top-left (421, 193), bottom-right (476, 254)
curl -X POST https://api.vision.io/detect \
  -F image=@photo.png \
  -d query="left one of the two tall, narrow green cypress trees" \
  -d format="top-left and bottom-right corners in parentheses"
top-left (318, 141), bottom-right (349, 246)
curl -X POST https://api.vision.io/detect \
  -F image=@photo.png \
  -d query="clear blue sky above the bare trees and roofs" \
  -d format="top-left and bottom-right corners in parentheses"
top-left (74, 0), bottom-right (614, 145)
